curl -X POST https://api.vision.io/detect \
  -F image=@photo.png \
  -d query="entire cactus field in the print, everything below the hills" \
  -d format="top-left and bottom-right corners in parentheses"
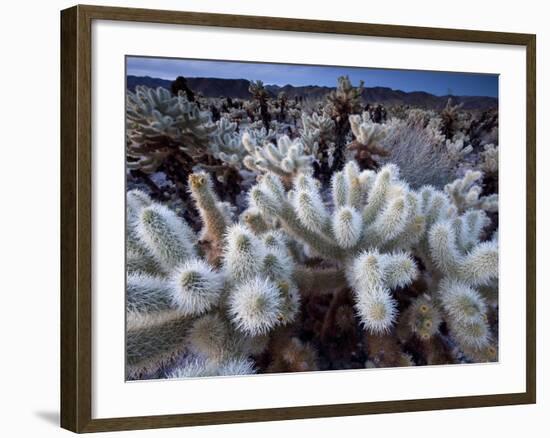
top-left (126, 72), bottom-right (498, 379)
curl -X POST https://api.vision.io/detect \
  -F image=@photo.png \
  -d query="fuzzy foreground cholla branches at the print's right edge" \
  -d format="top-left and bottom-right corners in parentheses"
top-left (422, 189), bottom-right (498, 356)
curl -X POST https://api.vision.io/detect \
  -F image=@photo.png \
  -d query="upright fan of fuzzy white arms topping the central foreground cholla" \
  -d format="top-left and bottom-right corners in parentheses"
top-left (250, 162), bottom-right (423, 260)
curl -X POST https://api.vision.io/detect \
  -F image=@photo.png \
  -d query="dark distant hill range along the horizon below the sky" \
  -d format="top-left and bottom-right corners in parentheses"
top-left (126, 75), bottom-right (498, 110)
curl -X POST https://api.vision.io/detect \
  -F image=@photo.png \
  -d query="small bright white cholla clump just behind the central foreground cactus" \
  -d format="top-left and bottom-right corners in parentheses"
top-left (242, 132), bottom-right (314, 185)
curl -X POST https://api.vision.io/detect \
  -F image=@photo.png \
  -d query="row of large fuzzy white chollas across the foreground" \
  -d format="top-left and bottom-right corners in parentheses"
top-left (127, 155), bottom-right (498, 378)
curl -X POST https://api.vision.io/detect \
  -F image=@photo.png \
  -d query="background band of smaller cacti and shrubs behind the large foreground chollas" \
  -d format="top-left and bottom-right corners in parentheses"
top-left (127, 77), bottom-right (498, 194)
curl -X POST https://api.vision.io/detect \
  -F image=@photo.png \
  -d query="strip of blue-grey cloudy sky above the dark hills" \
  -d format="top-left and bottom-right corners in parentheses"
top-left (127, 57), bottom-right (498, 97)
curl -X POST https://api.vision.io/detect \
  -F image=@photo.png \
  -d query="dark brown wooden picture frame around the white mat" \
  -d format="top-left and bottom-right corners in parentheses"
top-left (61, 5), bottom-right (536, 433)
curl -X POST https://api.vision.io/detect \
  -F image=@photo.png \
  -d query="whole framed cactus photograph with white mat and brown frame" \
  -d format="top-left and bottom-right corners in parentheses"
top-left (61, 6), bottom-right (536, 432)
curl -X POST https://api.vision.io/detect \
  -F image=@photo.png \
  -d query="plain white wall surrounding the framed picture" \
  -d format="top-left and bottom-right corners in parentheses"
top-left (0, 0), bottom-right (550, 438)
